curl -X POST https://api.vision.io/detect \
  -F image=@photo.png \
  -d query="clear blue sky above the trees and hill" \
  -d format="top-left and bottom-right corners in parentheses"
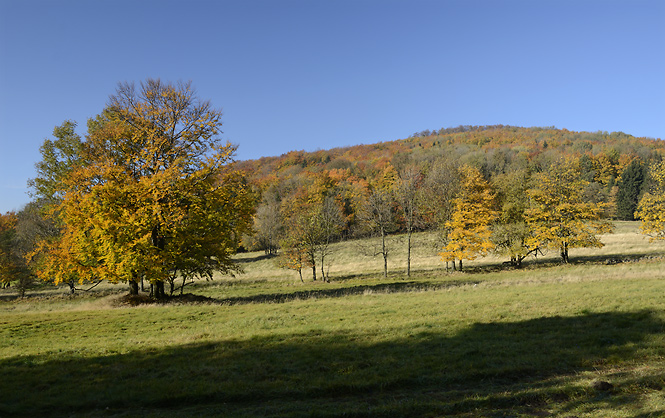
top-left (0, 0), bottom-right (665, 213)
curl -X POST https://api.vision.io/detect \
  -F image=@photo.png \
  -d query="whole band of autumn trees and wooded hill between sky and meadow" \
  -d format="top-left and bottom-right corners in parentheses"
top-left (0, 79), bottom-right (665, 298)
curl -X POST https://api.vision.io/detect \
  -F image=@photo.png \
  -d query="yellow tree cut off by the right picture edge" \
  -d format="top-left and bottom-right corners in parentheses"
top-left (635, 161), bottom-right (665, 240)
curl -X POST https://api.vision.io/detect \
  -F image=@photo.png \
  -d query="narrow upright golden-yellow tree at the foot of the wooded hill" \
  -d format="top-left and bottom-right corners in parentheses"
top-left (440, 166), bottom-right (497, 270)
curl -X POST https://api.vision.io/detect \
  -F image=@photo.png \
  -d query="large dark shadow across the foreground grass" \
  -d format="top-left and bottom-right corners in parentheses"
top-left (0, 311), bottom-right (665, 416)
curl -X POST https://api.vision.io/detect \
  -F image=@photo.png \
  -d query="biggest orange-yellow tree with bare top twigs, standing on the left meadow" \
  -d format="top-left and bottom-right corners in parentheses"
top-left (31, 79), bottom-right (253, 298)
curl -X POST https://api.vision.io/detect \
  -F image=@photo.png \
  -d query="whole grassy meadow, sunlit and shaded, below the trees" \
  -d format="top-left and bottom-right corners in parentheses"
top-left (0, 223), bottom-right (665, 418)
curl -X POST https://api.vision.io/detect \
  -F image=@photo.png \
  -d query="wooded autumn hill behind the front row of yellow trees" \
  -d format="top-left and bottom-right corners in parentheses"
top-left (235, 125), bottom-right (665, 268)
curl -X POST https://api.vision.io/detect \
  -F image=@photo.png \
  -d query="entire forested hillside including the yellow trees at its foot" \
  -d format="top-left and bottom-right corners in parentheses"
top-left (236, 125), bottom-right (665, 278)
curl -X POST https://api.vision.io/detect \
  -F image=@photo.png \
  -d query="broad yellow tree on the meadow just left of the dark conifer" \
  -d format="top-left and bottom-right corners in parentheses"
top-left (525, 159), bottom-right (612, 263)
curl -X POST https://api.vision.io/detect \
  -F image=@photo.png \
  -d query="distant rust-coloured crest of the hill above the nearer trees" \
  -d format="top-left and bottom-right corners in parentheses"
top-left (237, 125), bottom-right (665, 188)
